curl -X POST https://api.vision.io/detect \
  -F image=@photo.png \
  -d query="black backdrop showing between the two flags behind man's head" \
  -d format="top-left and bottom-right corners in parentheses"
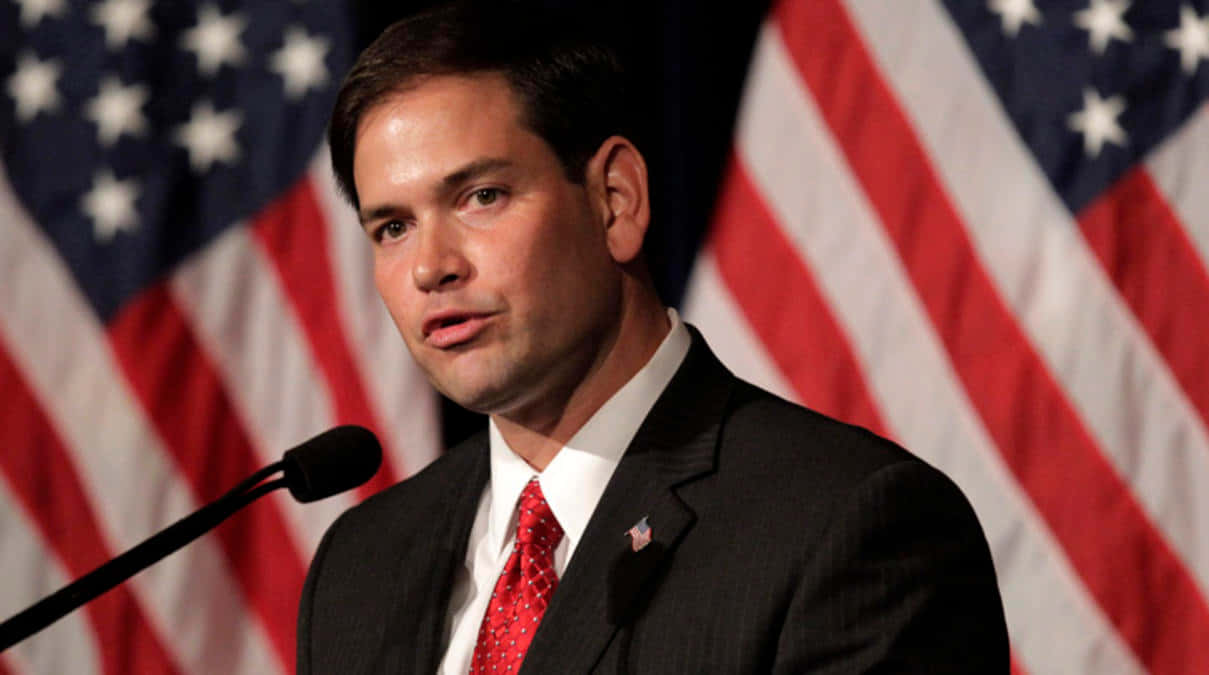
top-left (352, 0), bottom-right (768, 445)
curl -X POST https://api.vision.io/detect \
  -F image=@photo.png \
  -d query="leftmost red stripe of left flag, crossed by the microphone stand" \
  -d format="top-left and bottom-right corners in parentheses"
top-left (0, 336), bottom-right (180, 674)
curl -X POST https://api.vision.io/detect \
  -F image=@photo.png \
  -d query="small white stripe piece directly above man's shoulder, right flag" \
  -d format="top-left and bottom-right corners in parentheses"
top-left (683, 252), bottom-right (799, 400)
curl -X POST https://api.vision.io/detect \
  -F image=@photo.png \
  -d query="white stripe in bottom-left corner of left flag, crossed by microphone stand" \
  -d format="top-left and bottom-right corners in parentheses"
top-left (0, 488), bottom-right (100, 673)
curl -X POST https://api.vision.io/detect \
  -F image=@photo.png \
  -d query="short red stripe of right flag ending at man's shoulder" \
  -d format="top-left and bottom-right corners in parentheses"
top-left (708, 156), bottom-right (886, 435)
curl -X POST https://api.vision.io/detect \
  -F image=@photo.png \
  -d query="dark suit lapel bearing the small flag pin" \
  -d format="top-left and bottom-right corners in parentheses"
top-left (521, 327), bottom-right (734, 673)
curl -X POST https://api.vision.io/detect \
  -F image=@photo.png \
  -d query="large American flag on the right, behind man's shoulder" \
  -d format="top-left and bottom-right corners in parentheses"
top-left (686, 0), bottom-right (1209, 674)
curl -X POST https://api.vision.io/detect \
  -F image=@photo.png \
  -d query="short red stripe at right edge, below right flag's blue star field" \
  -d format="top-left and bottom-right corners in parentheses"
top-left (1078, 166), bottom-right (1209, 433)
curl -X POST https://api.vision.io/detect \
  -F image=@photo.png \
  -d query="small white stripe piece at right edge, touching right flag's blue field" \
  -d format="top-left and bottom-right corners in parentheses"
top-left (1146, 104), bottom-right (1209, 270)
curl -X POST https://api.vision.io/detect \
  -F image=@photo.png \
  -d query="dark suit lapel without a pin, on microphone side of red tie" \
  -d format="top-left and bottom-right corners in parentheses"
top-left (372, 433), bottom-right (491, 673)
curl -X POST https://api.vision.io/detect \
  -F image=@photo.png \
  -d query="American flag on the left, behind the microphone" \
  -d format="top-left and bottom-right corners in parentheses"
top-left (0, 0), bottom-right (438, 674)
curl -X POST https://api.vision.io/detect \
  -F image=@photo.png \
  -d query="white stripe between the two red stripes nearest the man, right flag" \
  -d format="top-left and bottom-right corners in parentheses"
top-left (715, 23), bottom-right (1141, 673)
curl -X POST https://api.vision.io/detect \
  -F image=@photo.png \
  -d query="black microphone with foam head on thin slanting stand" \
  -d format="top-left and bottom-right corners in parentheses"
top-left (0, 425), bottom-right (382, 652)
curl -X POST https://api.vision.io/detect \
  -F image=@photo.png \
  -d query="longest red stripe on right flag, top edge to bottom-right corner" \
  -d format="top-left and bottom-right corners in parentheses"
top-left (777, 0), bottom-right (1209, 673)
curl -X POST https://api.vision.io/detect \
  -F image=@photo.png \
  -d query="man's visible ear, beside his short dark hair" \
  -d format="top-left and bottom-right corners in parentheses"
top-left (589, 135), bottom-right (650, 264)
